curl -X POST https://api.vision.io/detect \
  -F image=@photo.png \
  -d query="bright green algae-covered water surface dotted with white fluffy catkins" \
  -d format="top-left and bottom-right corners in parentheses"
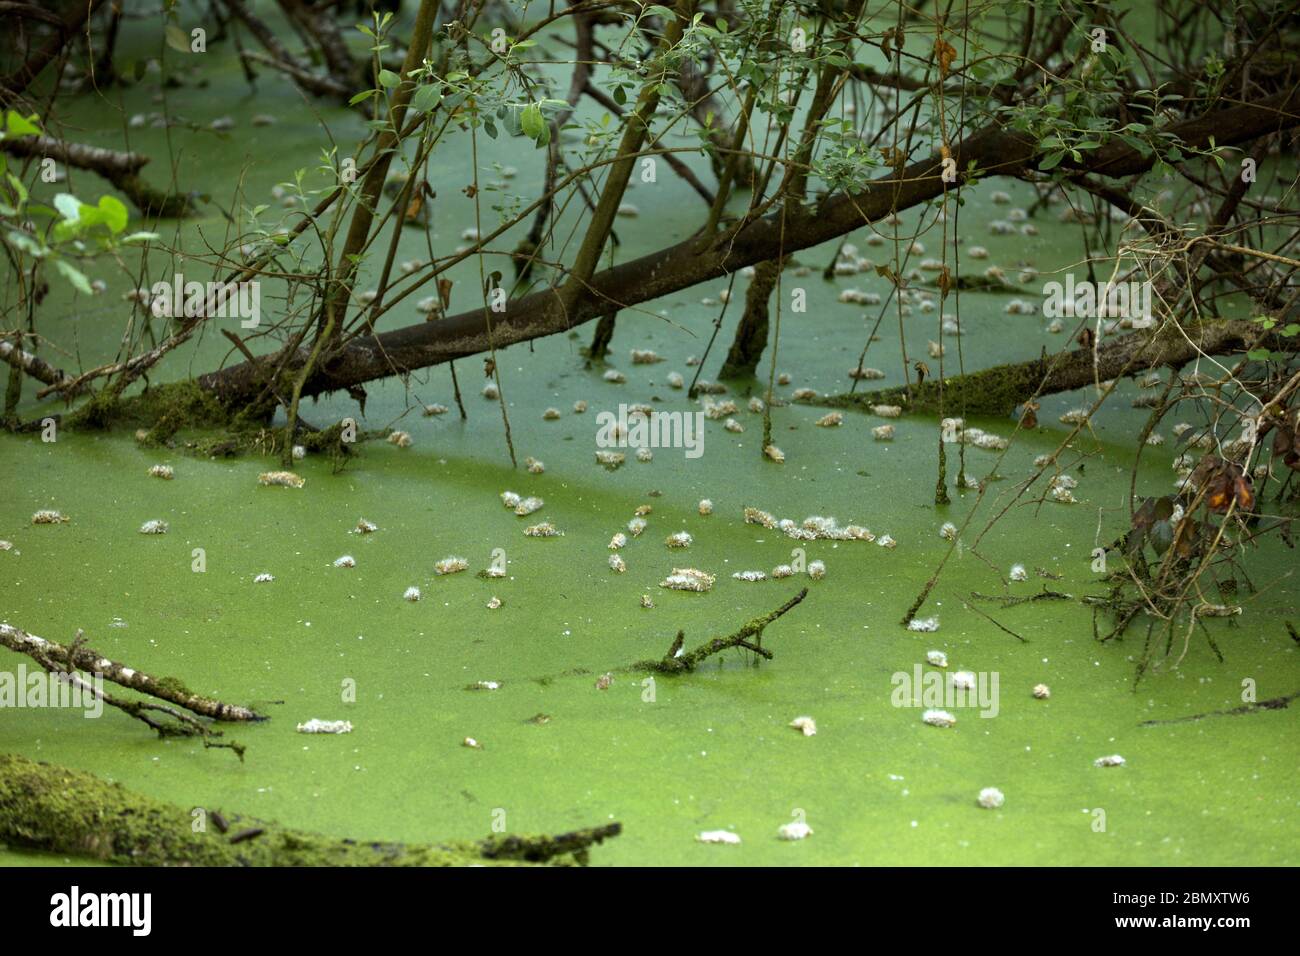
top-left (0, 5), bottom-right (1300, 865)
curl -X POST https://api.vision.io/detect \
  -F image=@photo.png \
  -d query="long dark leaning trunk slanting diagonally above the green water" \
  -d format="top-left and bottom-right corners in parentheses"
top-left (199, 88), bottom-right (1300, 416)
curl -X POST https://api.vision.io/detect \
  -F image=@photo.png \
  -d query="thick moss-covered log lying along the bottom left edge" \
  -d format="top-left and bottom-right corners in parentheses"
top-left (0, 754), bottom-right (621, 866)
